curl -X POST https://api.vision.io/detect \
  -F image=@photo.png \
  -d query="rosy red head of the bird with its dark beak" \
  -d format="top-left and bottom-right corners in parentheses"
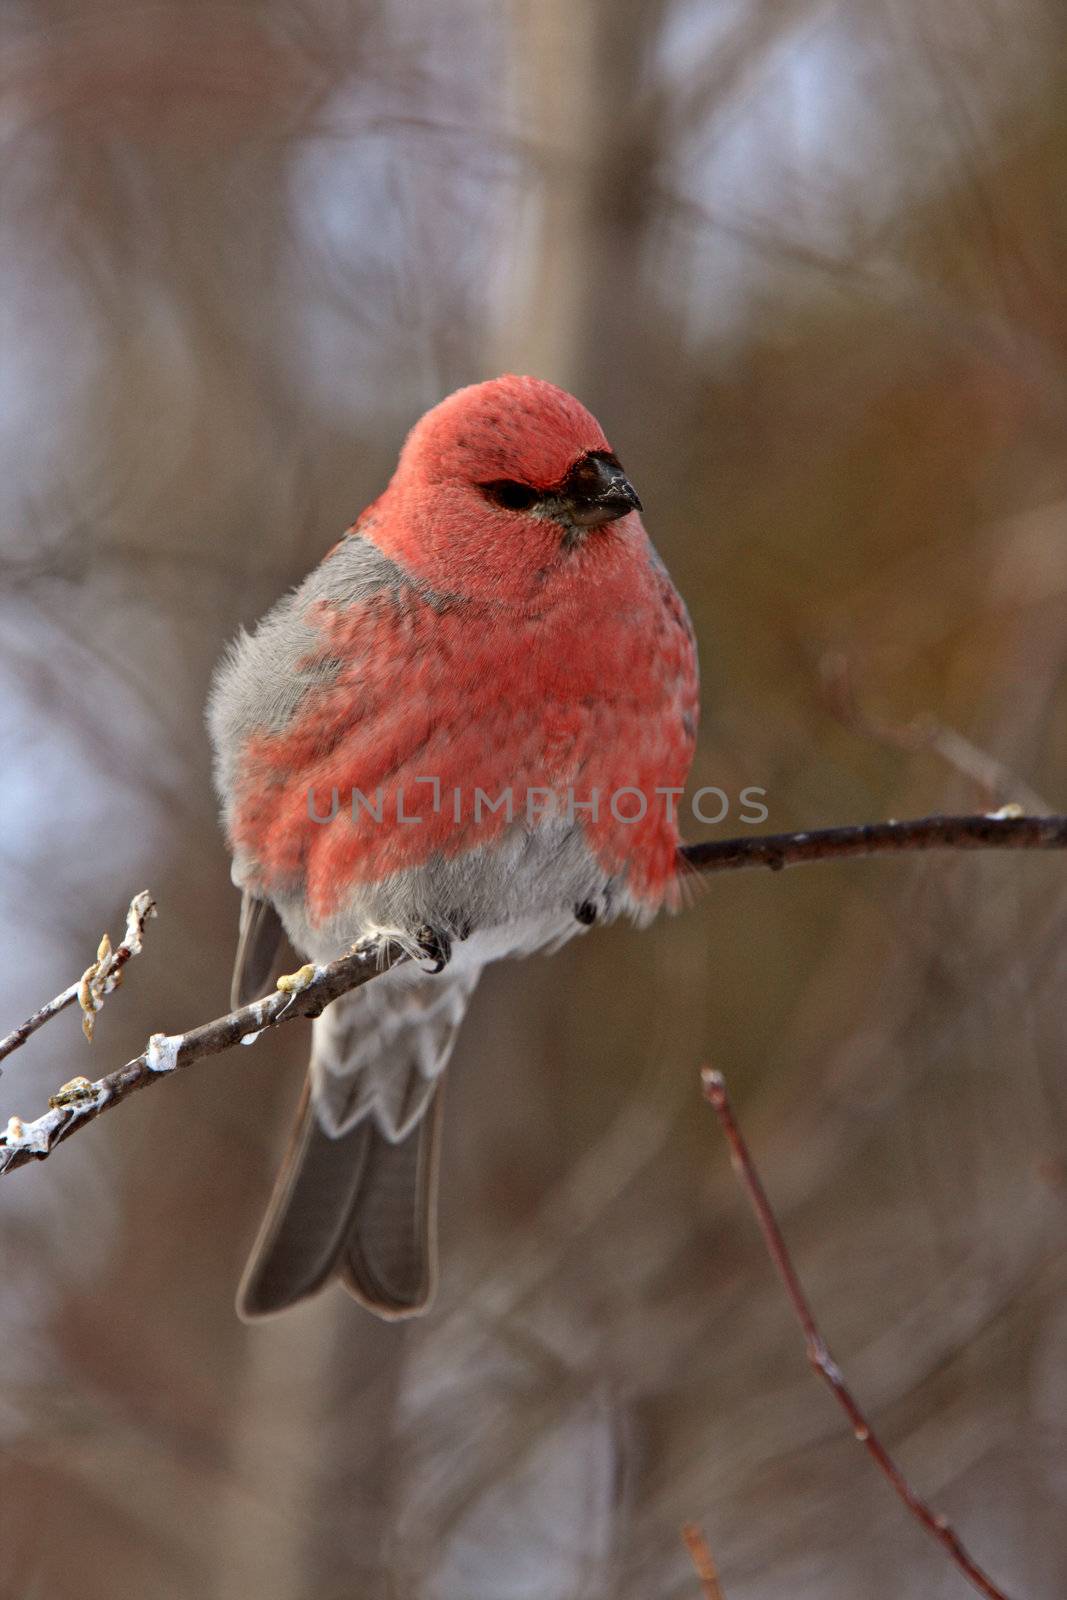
top-left (366, 374), bottom-right (643, 602)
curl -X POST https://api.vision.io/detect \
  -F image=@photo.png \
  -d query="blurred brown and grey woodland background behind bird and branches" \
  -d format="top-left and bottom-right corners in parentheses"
top-left (0, 0), bottom-right (1067, 1600)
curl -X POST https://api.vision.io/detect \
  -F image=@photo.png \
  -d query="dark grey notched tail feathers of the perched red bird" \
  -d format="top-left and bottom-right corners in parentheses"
top-left (237, 1080), bottom-right (443, 1320)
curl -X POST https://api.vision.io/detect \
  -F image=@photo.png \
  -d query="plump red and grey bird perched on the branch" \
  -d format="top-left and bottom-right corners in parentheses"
top-left (210, 376), bottom-right (697, 1317)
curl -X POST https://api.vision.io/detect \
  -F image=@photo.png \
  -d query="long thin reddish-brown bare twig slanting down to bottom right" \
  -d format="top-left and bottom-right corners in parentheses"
top-left (701, 1067), bottom-right (1008, 1600)
